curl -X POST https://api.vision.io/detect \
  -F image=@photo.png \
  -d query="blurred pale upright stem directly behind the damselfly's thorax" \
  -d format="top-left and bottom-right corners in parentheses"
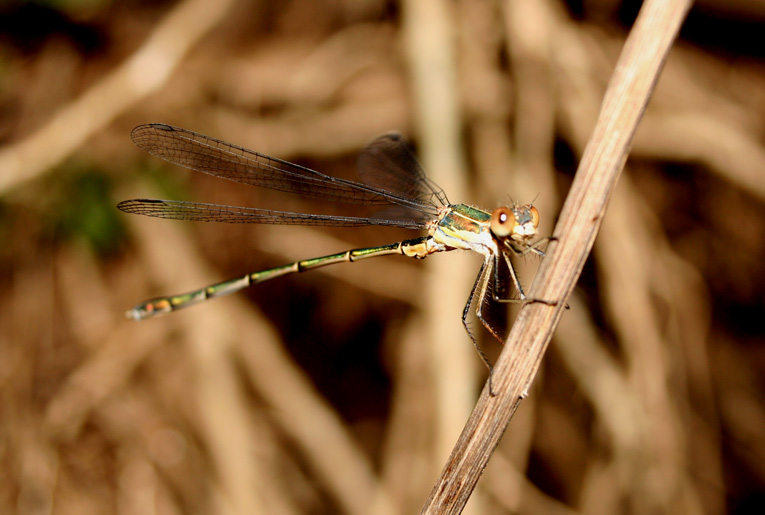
top-left (402, 0), bottom-right (476, 484)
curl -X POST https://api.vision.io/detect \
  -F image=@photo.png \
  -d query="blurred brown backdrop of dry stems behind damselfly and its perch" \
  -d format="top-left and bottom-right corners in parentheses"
top-left (0, 0), bottom-right (765, 514)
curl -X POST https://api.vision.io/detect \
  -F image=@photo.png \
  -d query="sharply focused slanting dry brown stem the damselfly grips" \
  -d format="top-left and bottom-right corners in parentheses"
top-left (421, 0), bottom-right (691, 514)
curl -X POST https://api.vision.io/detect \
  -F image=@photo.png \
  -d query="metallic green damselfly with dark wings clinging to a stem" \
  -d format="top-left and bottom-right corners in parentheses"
top-left (117, 124), bottom-right (545, 369)
